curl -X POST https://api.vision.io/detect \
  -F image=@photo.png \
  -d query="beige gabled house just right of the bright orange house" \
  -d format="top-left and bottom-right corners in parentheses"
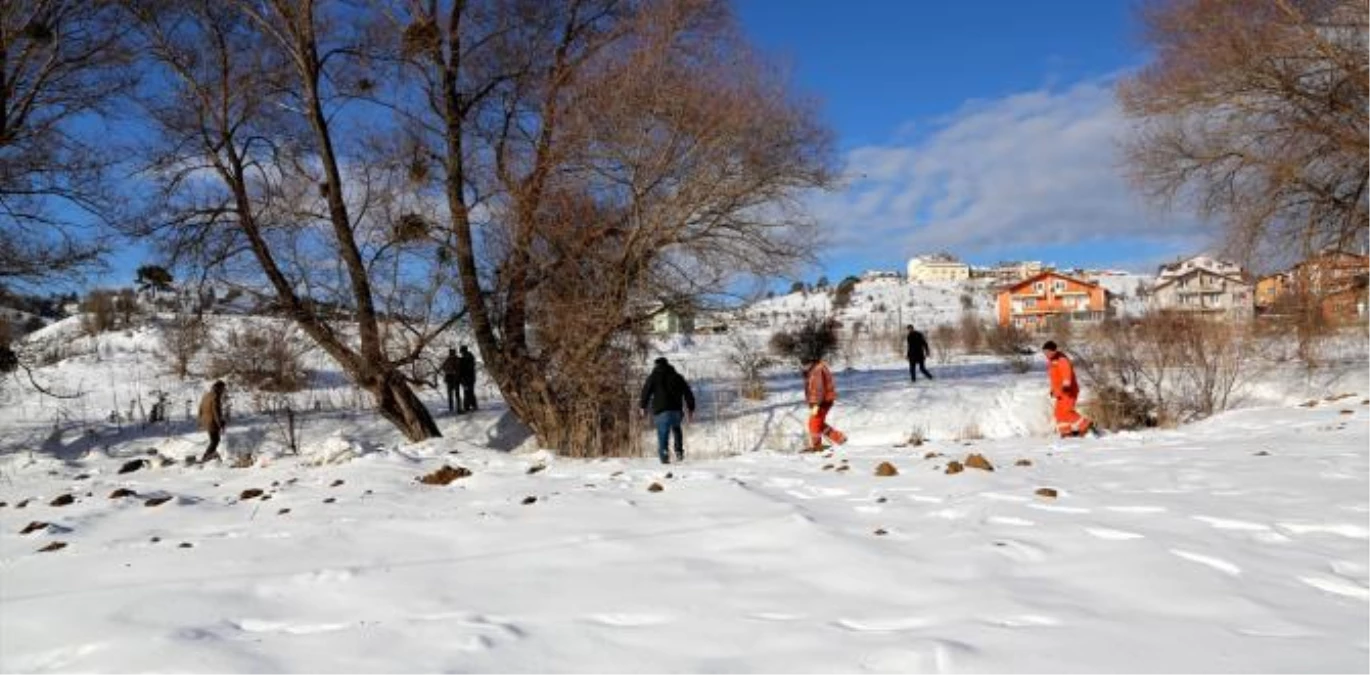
top-left (1147, 256), bottom-right (1255, 319)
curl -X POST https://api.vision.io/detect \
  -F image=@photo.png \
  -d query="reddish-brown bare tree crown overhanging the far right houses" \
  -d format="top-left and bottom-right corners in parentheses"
top-left (1119, 0), bottom-right (1370, 256)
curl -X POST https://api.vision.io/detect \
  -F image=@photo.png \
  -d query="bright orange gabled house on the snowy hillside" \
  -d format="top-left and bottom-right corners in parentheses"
top-left (999, 271), bottom-right (1108, 330)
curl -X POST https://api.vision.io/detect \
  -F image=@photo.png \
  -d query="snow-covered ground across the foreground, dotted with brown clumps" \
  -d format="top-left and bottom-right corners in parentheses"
top-left (0, 317), bottom-right (1370, 675)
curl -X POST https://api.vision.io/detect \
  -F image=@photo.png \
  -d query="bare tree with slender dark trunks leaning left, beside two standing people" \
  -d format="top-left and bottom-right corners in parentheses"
top-left (129, 0), bottom-right (462, 441)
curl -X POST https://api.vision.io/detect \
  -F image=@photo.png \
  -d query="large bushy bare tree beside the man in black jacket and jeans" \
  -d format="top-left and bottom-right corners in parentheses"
top-left (395, 0), bottom-right (832, 455)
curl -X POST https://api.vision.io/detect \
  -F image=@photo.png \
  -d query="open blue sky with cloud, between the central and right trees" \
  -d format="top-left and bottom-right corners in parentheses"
top-left (738, 0), bottom-right (1211, 277)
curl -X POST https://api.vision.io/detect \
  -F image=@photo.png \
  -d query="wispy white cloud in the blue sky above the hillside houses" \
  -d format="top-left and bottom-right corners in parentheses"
top-left (814, 81), bottom-right (1206, 260)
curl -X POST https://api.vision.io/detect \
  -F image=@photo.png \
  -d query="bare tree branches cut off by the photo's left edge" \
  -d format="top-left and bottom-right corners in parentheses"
top-left (0, 0), bottom-right (133, 282)
